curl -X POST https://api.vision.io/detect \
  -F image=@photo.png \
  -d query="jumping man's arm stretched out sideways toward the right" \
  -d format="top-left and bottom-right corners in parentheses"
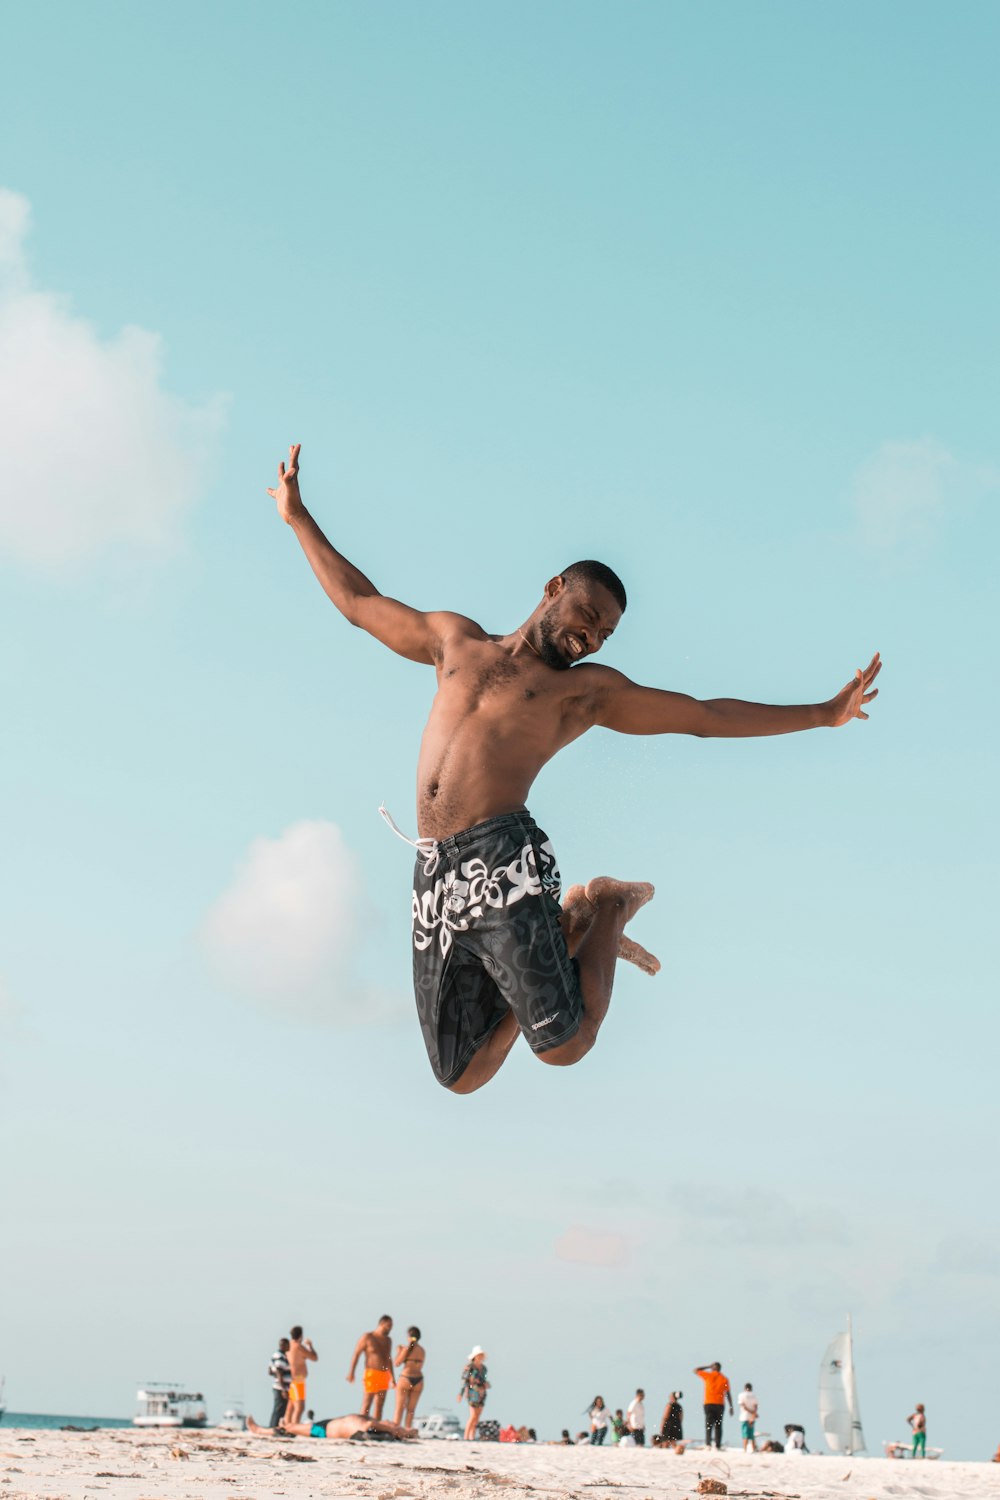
top-left (595, 651), bottom-right (882, 740)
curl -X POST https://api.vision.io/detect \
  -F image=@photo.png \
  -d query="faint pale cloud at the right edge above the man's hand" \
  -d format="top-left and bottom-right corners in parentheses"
top-left (852, 438), bottom-right (1000, 552)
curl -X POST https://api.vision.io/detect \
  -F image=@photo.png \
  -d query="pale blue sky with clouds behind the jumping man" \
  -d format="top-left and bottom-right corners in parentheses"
top-left (0, 0), bottom-right (1000, 1457)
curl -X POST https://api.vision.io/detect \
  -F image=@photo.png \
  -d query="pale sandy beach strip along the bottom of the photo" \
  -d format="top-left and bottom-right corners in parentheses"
top-left (0, 1428), bottom-right (1000, 1500)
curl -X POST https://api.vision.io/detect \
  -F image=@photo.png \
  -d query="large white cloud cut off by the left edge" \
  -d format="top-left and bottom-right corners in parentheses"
top-left (0, 189), bottom-right (225, 569)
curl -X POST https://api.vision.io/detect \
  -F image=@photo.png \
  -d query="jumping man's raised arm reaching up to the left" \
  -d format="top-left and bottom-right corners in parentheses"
top-left (267, 443), bottom-right (475, 666)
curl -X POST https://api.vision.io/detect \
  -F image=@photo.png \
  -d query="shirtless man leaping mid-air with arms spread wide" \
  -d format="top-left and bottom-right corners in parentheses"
top-left (268, 444), bottom-right (880, 1094)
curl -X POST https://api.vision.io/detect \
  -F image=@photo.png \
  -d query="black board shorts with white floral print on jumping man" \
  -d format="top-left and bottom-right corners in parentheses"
top-left (414, 813), bottom-right (583, 1088)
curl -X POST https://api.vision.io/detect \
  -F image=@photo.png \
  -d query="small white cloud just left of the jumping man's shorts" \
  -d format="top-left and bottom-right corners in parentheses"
top-left (201, 822), bottom-right (405, 1026)
